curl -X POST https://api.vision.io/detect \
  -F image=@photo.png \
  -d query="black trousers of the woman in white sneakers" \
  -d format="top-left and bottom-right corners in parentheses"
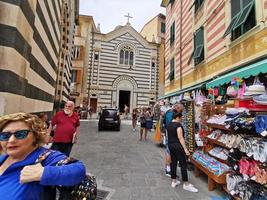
top-left (168, 144), bottom-right (188, 181)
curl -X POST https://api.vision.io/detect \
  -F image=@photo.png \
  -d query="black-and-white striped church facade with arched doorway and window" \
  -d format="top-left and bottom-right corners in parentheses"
top-left (88, 23), bottom-right (159, 111)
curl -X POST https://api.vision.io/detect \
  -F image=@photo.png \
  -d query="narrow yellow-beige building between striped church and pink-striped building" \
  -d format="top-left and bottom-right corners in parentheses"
top-left (140, 14), bottom-right (165, 96)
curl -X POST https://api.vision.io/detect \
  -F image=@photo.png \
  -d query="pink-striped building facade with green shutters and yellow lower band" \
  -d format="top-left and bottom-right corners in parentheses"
top-left (161, 0), bottom-right (267, 97)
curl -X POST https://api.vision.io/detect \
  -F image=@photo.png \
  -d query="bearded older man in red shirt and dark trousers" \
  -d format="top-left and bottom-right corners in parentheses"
top-left (51, 101), bottom-right (80, 156)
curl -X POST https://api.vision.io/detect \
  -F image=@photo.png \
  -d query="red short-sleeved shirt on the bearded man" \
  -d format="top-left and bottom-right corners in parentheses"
top-left (52, 111), bottom-right (80, 143)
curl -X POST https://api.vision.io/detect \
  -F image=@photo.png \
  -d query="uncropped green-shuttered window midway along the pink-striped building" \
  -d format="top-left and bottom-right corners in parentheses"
top-left (188, 27), bottom-right (205, 65)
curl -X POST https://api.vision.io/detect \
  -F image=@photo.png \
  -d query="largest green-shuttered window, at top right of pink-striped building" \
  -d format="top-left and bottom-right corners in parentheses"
top-left (223, 0), bottom-right (256, 41)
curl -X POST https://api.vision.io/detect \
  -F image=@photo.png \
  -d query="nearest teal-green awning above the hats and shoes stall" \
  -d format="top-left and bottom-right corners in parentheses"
top-left (206, 59), bottom-right (267, 89)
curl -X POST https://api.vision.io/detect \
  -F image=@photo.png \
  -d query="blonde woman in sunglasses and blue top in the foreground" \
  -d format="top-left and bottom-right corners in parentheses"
top-left (0, 113), bottom-right (85, 200)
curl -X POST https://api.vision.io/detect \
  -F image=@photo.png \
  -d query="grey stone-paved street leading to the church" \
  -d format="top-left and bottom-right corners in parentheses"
top-left (72, 120), bottom-right (226, 200)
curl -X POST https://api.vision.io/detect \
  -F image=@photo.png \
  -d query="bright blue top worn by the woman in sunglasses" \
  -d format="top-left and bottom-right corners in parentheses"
top-left (0, 147), bottom-right (86, 200)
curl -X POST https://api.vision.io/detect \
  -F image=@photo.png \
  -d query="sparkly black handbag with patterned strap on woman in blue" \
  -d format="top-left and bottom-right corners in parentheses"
top-left (35, 149), bottom-right (97, 200)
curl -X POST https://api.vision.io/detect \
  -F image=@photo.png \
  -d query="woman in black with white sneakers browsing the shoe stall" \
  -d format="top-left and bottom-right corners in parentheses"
top-left (167, 112), bottom-right (198, 192)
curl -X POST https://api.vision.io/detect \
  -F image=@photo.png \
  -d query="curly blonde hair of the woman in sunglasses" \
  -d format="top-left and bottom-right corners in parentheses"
top-left (0, 112), bottom-right (47, 146)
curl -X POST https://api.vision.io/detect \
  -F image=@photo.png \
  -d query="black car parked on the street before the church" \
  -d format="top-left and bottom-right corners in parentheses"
top-left (98, 108), bottom-right (121, 131)
